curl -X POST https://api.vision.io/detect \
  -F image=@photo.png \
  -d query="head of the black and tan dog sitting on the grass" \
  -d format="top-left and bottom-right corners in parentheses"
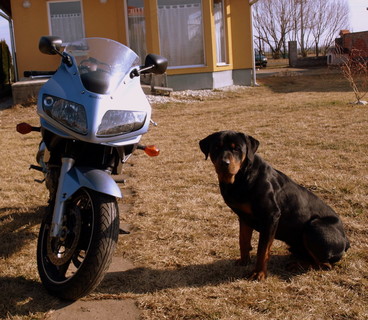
top-left (199, 131), bottom-right (259, 183)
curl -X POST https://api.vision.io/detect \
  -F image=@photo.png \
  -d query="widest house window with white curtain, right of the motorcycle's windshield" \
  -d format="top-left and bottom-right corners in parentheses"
top-left (158, 0), bottom-right (205, 67)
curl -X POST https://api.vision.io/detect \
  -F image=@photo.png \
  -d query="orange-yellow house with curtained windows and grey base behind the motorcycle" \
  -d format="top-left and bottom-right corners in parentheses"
top-left (0, 0), bottom-right (253, 90)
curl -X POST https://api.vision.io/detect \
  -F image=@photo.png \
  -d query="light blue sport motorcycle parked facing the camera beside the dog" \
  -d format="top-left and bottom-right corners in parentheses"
top-left (17, 36), bottom-right (167, 300)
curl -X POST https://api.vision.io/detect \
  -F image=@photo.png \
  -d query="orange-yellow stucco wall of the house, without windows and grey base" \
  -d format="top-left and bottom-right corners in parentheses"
top-left (11, 0), bottom-right (252, 77)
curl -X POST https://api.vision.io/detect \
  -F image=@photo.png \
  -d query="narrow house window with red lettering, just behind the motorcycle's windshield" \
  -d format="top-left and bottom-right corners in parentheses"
top-left (126, 0), bottom-right (147, 61)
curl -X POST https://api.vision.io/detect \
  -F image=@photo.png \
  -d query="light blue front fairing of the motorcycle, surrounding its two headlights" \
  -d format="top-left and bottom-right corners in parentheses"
top-left (37, 39), bottom-right (151, 146)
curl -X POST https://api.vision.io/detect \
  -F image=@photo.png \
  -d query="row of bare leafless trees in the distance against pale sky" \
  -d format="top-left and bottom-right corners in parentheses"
top-left (252, 0), bottom-right (349, 59)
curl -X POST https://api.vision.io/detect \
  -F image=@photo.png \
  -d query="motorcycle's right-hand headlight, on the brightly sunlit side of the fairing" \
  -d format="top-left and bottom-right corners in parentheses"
top-left (97, 110), bottom-right (147, 136)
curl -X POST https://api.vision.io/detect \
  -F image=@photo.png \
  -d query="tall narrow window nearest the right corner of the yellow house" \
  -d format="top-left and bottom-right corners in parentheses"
top-left (213, 0), bottom-right (227, 65)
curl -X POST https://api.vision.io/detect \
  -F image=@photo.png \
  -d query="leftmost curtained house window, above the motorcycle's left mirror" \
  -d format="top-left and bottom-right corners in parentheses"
top-left (48, 1), bottom-right (84, 43)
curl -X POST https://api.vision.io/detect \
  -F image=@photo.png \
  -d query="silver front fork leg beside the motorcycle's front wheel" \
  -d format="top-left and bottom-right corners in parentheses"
top-left (50, 157), bottom-right (75, 238)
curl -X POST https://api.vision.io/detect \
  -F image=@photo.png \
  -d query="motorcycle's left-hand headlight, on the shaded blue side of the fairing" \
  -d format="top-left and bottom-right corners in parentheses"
top-left (42, 95), bottom-right (88, 134)
